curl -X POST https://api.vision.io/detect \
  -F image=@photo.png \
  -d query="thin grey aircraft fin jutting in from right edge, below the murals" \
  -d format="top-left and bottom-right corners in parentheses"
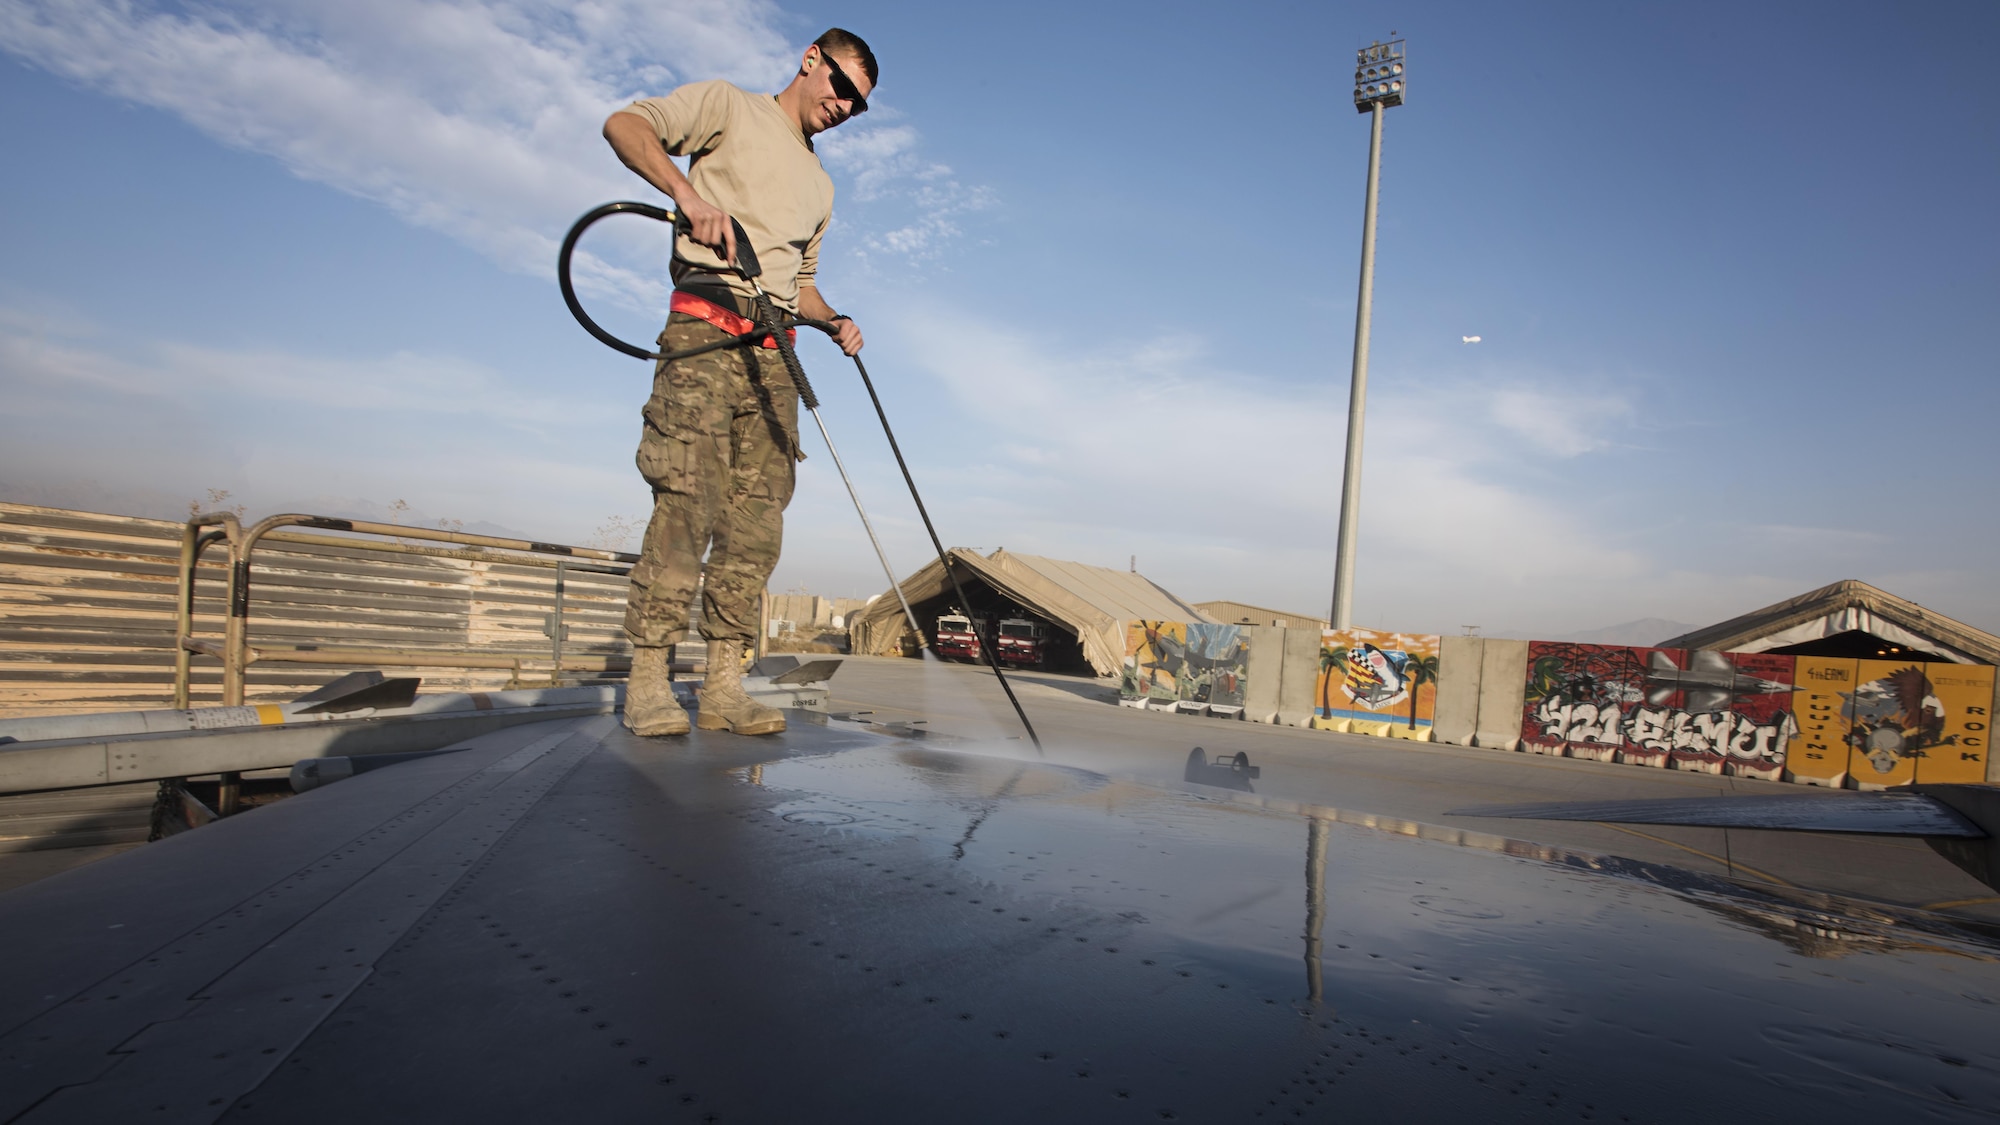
top-left (1450, 793), bottom-right (1986, 839)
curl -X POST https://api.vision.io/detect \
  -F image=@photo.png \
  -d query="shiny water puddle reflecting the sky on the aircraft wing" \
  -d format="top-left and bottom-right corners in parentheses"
top-left (744, 745), bottom-right (2000, 1119)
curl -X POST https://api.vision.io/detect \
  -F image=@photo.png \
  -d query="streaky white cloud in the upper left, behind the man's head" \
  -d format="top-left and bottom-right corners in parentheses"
top-left (0, 0), bottom-right (980, 296)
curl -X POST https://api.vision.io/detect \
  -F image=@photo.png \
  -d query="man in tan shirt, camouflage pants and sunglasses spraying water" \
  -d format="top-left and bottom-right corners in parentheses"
top-left (604, 28), bottom-right (876, 735)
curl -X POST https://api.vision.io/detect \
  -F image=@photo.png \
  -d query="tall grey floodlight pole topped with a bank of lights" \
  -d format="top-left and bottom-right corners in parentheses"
top-left (1328, 40), bottom-right (1406, 629)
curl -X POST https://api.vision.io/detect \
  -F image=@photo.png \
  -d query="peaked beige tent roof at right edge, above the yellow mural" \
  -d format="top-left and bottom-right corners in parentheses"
top-left (1660, 579), bottom-right (2000, 665)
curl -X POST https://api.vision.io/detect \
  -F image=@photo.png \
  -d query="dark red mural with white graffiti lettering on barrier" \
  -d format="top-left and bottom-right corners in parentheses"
top-left (1520, 641), bottom-right (1798, 779)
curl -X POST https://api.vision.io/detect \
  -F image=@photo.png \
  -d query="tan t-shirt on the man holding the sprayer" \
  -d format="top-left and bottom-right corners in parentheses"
top-left (618, 80), bottom-right (834, 312)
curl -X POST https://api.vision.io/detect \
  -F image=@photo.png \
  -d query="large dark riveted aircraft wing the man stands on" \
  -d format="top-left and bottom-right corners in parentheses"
top-left (0, 717), bottom-right (2000, 1123)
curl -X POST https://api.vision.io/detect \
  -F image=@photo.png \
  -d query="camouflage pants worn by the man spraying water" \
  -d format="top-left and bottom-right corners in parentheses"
top-left (626, 312), bottom-right (798, 647)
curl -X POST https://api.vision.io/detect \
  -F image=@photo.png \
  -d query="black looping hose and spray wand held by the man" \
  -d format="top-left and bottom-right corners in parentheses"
top-left (556, 202), bottom-right (1046, 757)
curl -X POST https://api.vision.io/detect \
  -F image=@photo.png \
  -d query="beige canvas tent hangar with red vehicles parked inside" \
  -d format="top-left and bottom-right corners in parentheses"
top-left (848, 546), bottom-right (1210, 677)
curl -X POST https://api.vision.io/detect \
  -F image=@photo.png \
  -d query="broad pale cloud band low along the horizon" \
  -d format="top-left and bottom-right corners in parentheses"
top-left (0, 298), bottom-right (1992, 637)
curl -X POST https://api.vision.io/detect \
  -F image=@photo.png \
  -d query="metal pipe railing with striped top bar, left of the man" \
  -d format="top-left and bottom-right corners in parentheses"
top-left (174, 512), bottom-right (672, 707)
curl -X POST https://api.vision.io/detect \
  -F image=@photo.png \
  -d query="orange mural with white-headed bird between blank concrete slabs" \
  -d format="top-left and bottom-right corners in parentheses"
top-left (1312, 629), bottom-right (1438, 741)
